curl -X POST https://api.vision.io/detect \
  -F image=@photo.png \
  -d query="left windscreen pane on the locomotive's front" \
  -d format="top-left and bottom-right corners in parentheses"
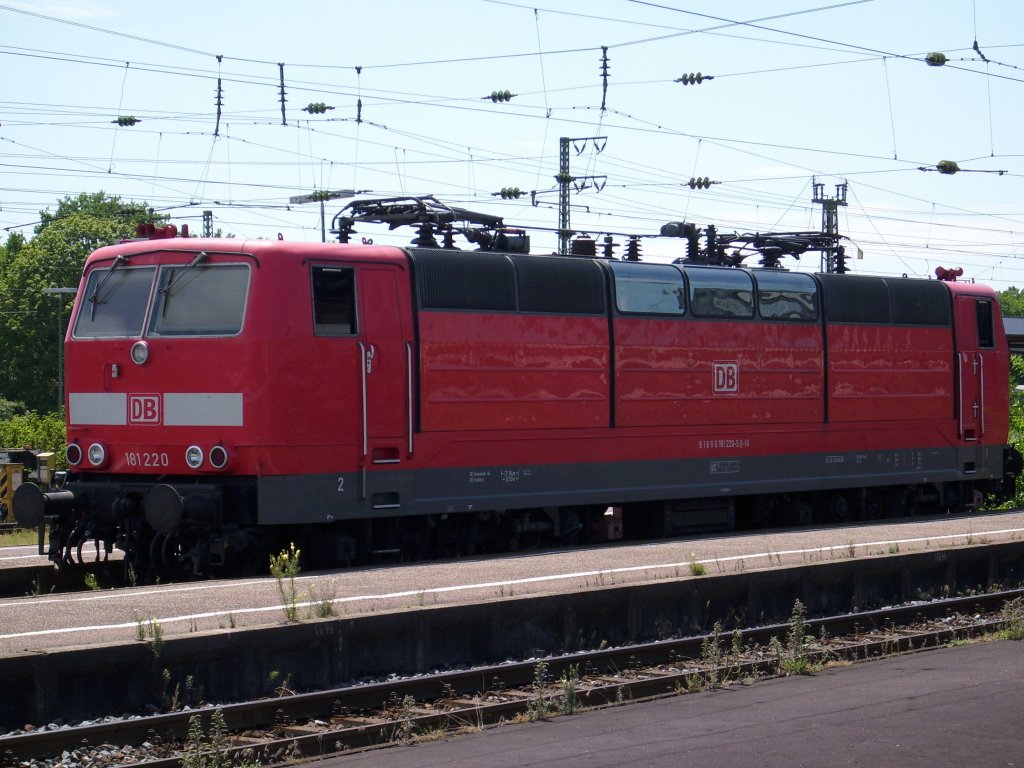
top-left (74, 264), bottom-right (157, 339)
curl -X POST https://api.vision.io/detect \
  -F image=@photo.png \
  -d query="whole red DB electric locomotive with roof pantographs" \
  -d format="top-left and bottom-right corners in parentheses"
top-left (13, 199), bottom-right (1019, 574)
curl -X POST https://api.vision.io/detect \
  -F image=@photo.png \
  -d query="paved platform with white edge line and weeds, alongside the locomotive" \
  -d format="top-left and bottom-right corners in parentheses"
top-left (0, 511), bottom-right (1024, 655)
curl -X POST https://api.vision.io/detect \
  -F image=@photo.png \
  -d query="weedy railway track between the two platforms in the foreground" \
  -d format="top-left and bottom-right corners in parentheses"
top-left (0, 590), bottom-right (1024, 768)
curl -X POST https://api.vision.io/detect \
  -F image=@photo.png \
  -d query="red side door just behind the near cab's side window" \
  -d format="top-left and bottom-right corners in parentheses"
top-left (358, 264), bottom-right (413, 465)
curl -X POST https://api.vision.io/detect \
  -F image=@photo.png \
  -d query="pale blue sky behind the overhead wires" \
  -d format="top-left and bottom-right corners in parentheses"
top-left (0, 0), bottom-right (1024, 290)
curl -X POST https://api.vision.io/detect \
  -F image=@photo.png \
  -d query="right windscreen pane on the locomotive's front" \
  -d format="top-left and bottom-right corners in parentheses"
top-left (150, 264), bottom-right (249, 336)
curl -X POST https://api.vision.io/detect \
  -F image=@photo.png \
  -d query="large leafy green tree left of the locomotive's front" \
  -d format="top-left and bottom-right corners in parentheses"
top-left (0, 193), bottom-right (166, 413)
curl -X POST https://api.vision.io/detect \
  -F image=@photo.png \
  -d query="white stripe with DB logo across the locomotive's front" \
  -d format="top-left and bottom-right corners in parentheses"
top-left (68, 392), bottom-right (245, 427)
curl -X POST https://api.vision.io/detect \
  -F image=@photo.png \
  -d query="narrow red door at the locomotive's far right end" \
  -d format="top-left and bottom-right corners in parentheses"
top-left (953, 296), bottom-right (995, 441)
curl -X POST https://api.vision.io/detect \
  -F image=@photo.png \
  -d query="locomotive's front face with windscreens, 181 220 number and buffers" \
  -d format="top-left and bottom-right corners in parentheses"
top-left (20, 239), bottom-right (255, 575)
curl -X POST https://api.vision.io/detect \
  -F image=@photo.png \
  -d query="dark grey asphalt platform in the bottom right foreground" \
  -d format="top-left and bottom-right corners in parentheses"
top-left (317, 641), bottom-right (1024, 768)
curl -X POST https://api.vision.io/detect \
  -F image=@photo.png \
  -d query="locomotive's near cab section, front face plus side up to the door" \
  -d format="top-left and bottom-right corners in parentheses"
top-left (16, 228), bottom-right (413, 578)
